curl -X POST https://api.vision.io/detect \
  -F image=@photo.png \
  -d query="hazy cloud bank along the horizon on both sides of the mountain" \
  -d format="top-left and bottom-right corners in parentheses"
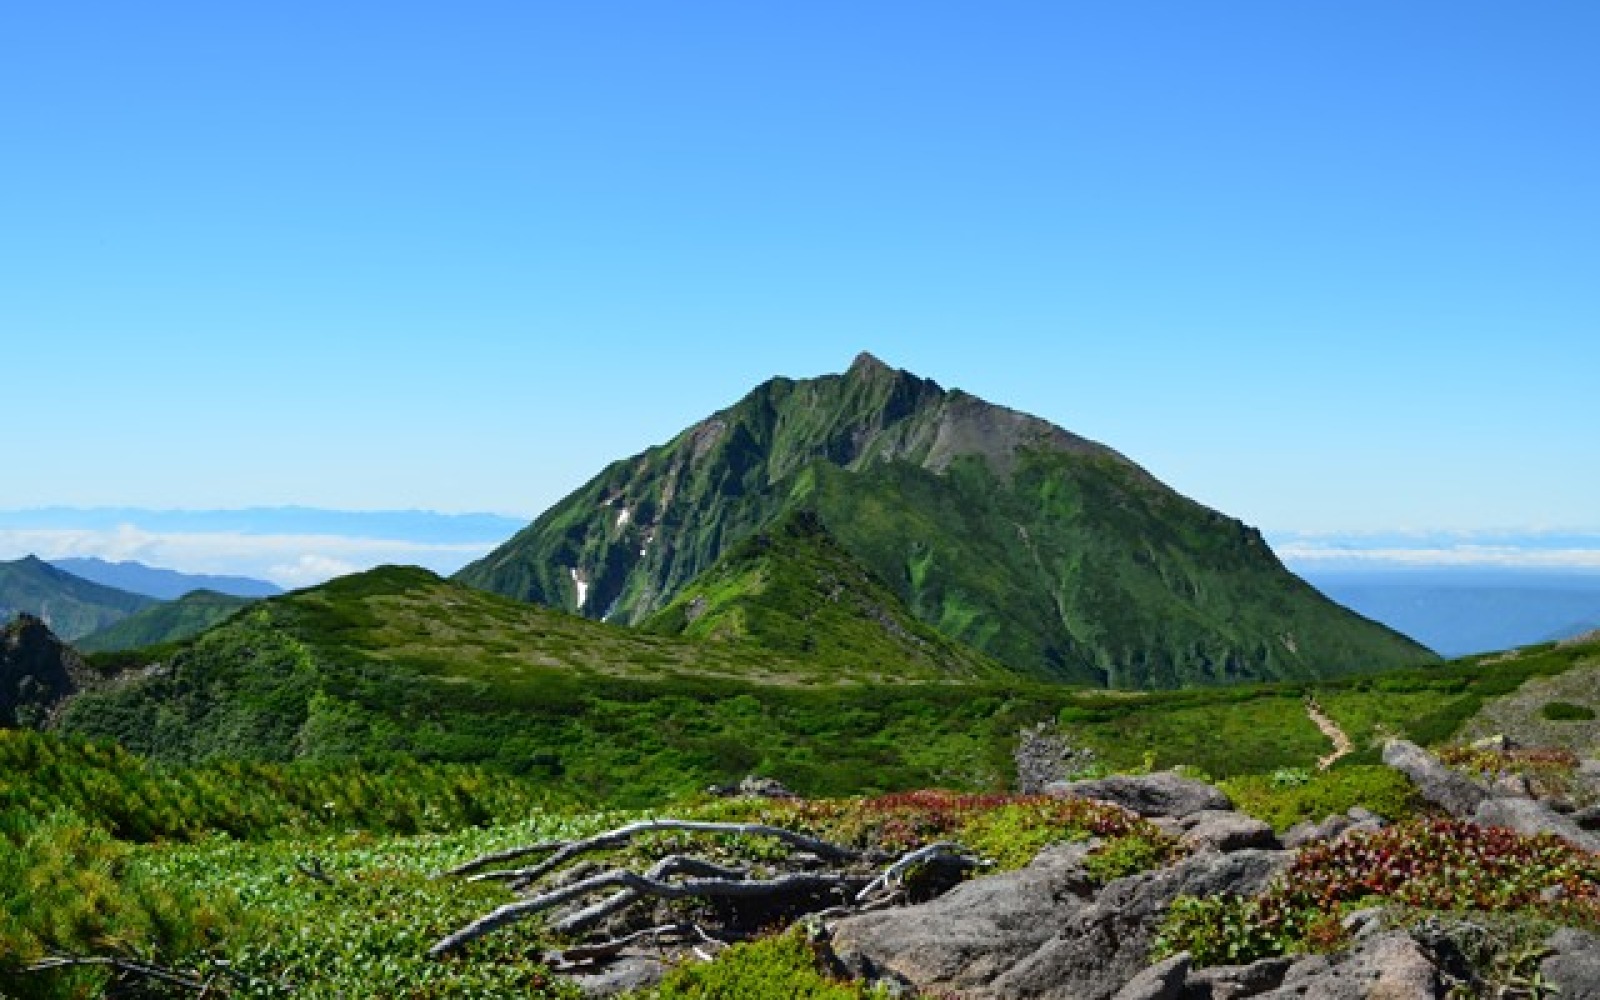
top-left (0, 507), bottom-right (1600, 589)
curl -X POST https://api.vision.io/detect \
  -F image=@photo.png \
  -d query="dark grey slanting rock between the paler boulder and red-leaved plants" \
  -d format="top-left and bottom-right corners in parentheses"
top-left (990, 851), bottom-right (1291, 1000)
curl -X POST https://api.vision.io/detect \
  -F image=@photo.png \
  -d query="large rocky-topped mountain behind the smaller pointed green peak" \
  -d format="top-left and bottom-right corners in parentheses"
top-left (458, 355), bottom-right (1435, 688)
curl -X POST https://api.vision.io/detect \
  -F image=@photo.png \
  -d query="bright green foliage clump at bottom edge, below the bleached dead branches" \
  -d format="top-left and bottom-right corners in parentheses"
top-left (646, 931), bottom-right (886, 1000)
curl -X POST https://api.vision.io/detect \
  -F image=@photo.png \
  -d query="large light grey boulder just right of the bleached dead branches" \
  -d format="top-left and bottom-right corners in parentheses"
top-left (832, 843), bottom-right (1096, 995)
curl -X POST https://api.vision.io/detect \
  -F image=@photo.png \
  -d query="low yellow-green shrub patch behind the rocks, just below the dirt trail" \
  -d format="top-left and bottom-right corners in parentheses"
top-left (1221, 765), bottom-right (1422, 832)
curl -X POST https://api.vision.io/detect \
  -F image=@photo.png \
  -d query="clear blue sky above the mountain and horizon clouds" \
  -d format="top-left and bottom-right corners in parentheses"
top-left (0, 0), bottom-right (1600, 533)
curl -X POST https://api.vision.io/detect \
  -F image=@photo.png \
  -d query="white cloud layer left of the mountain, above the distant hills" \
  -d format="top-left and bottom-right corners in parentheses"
top-left (0, 525), bottom-right (496, 587)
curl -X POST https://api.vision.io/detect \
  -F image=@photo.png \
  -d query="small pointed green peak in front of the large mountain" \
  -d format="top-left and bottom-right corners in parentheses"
top-left (645, 512), bottom-right (1005, 678)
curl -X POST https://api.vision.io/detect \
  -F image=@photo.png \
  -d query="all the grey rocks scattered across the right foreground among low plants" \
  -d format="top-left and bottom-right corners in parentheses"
top-left (806, 741), bottom-right (1600, 1000)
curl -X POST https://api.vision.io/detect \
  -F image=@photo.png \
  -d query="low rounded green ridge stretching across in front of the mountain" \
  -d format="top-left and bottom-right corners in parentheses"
top-left (61, 568), bottom-right (1597, 805)
